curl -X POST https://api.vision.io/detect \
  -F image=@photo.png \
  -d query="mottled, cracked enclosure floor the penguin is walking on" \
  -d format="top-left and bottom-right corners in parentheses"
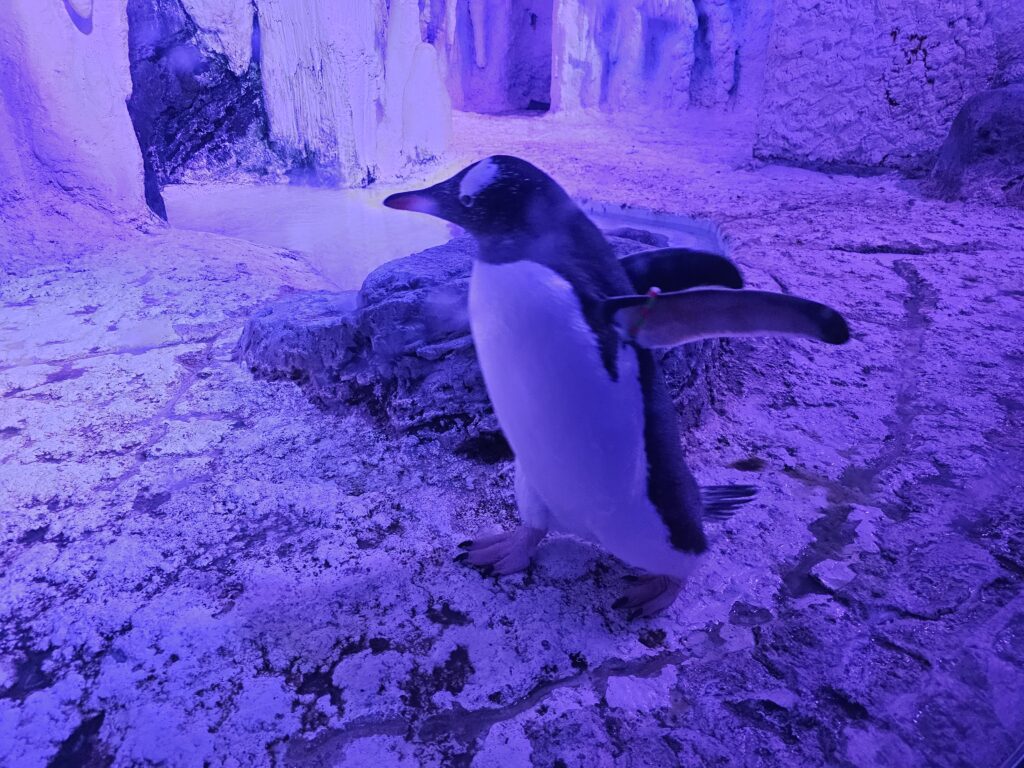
top-left (0, 116), bottom-right (1024, 768)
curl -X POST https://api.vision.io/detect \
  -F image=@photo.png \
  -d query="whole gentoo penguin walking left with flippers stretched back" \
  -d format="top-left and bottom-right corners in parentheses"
top-left (384, 155), bottom-right (849, 615)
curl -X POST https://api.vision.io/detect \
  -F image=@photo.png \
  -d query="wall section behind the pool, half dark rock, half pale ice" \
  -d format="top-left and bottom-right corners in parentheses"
top-left (130, 0), bottom-right (451, 186)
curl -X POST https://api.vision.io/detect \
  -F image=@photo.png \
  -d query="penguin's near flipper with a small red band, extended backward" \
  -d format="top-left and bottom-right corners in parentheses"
top-left (605, 289), bottom-right (850, 347)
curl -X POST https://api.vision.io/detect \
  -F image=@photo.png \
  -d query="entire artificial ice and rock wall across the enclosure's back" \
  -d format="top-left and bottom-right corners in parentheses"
top-left (0, 0), bottom-right (1024, 228)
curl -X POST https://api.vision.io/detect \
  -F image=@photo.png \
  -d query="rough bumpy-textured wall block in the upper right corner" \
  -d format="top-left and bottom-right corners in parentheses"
top-left (755, 0), bottom-right (1003, 169)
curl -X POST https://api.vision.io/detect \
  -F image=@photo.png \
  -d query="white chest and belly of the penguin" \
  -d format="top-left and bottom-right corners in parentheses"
top-left (469, 260), bottom-right (647, 529)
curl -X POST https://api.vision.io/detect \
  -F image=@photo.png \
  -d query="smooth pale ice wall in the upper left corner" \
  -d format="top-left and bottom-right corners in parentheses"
top-left (0, 0), bottom-right (144, 226)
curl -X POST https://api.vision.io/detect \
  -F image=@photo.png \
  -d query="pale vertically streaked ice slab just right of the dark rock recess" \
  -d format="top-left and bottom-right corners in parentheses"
top-left (258, 0), bottom-right (451, 185)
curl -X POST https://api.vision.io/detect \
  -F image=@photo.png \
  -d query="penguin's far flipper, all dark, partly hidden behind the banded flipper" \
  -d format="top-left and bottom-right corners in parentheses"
top-left (618, 248), bottom-right (743, 294)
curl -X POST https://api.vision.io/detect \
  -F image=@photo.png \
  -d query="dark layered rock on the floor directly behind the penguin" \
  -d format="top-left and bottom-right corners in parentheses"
top-left (237, 228), bottom-right (718, 454)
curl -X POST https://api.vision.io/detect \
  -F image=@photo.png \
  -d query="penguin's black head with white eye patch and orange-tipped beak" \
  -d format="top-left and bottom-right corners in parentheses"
top-left (384, 155), bottom-right (577, 238)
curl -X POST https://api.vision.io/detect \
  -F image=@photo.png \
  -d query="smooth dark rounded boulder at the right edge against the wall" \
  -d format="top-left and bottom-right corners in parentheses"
top-left (932, 85), bottom-right (1024, 207)
